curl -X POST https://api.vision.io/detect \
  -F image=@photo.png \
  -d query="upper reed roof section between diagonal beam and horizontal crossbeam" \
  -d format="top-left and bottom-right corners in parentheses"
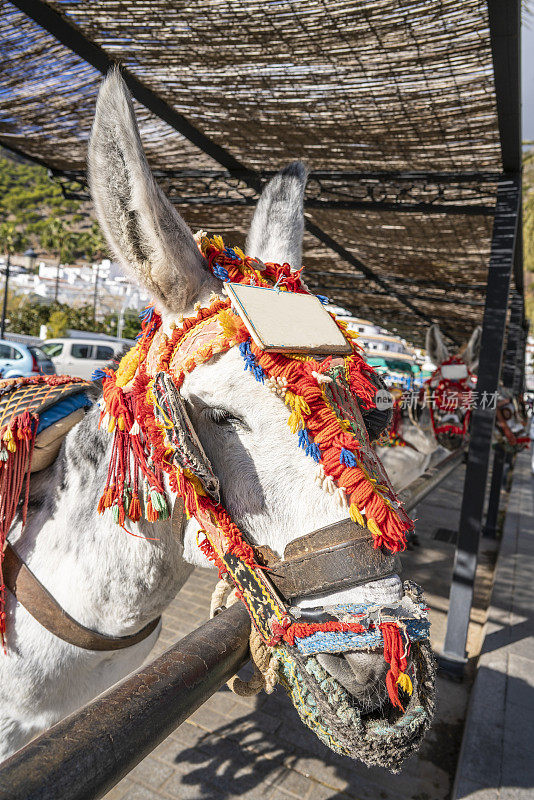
top-left (52, 0), bottom-right (500, 170)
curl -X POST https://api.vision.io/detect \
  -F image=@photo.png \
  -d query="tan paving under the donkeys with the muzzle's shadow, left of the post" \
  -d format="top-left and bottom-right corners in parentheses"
top-left (106, 468), bottom-right (498, 800)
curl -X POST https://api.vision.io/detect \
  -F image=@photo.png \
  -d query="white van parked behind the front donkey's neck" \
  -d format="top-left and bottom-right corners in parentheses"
top-left (41, 338), bottom-right (135, 380)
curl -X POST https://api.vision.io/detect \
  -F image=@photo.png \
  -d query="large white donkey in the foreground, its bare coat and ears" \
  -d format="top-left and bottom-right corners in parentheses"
top-left (0, 73), bottom-right (408, 758)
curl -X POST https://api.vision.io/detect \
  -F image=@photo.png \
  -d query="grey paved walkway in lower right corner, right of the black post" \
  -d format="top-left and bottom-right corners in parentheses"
top-left (454, 453), bottom-right (534, 800)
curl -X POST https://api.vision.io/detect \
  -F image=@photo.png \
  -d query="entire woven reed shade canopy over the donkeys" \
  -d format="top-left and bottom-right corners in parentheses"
top-left (0, 0), bottom-right (503, 344)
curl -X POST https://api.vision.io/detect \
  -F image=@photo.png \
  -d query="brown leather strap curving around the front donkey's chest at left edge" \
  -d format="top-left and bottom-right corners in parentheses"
top-left (2, 542), bottom-right (160, 650)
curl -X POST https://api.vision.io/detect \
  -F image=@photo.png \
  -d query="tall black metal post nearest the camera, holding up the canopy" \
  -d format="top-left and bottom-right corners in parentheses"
top-left (440, 175), bottom-right (521, 676)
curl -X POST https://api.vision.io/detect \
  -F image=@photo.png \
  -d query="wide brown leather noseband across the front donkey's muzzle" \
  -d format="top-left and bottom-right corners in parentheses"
top-left (256, 519), bottom-right (401, 600)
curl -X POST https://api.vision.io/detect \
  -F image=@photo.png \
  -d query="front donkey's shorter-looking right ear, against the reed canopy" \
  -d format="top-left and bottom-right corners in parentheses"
top-left (246, 161), bottom-right (308, 269)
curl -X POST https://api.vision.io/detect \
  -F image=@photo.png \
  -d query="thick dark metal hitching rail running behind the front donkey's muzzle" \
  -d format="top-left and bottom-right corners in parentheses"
top-left (0, 450), bottom-right (464, 800)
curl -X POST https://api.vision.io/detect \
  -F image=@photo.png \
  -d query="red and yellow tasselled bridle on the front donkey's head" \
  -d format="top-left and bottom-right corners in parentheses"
top-left (95, 236), bottom-right (427, 720)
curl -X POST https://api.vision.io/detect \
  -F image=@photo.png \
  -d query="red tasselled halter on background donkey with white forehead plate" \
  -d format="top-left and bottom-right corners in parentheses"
top-left (423, 356), bottom-right (473, 443)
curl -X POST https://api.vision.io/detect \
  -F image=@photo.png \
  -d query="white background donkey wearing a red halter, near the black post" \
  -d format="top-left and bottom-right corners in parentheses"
top-left (376, 324), bottom-right (482, 492)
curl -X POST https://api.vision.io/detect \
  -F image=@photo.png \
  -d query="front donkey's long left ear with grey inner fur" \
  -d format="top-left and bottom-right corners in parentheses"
top-left (89, 69), bottom-right (214, 313)
